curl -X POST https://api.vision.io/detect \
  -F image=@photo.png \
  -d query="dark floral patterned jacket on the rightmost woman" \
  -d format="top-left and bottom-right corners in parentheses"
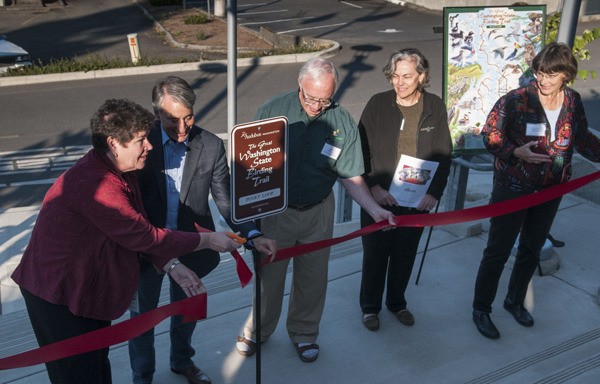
top-left (482, 85), bottom-right (600, 193)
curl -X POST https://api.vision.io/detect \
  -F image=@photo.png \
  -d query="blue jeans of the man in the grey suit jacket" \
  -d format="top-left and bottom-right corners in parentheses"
top-left (129, 260), bottom-right (196, 384)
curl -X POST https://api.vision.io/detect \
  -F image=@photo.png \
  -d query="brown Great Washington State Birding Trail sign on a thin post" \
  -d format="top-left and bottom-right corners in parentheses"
top-left (230, 117), bottom-right (288, 223)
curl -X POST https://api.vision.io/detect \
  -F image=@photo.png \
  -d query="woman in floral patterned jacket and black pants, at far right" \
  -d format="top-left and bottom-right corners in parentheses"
top-left (473, 43), bottom-right (600, 339)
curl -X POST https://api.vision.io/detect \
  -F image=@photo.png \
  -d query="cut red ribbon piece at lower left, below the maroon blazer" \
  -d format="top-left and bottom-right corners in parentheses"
top-left (0, 293), bottom-right (206, 370)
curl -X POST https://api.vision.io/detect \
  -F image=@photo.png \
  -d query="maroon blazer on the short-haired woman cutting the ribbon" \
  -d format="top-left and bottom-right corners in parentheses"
top-left (12, 150), bottom-right (200, 320)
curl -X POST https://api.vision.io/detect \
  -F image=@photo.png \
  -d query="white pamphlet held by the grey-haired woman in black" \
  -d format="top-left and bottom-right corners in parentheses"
top-left (389, 155), bottom-right (439, 208)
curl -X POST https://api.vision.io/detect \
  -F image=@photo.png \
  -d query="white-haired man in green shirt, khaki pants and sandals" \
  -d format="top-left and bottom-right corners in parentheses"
top-left (237, 58), bottom-right (394, 362)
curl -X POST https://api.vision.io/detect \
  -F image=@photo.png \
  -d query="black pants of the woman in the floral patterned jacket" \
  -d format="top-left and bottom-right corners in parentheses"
top-left (473, 185), bottom-right (561, 313)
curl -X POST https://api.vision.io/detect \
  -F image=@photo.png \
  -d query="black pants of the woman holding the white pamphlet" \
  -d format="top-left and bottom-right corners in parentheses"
top-left (359, 207), bottom-right (427, 314)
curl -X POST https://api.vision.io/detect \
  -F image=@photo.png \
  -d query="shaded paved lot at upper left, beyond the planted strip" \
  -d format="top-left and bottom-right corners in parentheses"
top-left (0, 0), bottom-right (204, 63)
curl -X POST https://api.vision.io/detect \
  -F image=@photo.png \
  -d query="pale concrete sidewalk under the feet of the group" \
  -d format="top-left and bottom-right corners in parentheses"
top-left (0, 172), bottom-right (600, 384)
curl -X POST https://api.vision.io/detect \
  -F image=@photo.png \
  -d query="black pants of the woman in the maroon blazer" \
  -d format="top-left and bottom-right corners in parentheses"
top-left (21, 288), bottom-right (112, 384)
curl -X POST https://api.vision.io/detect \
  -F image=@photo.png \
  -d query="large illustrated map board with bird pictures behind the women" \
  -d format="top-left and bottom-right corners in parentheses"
top-left (443, 5), bottom-right (546, 154)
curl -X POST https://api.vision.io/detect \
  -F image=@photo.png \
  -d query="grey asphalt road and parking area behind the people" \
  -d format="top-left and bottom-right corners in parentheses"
top-left (0, 0), bottom-right (600, 209)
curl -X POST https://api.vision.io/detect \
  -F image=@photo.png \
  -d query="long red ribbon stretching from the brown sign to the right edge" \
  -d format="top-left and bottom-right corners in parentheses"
top-left (261, 171), bottom-right (600, 266)
